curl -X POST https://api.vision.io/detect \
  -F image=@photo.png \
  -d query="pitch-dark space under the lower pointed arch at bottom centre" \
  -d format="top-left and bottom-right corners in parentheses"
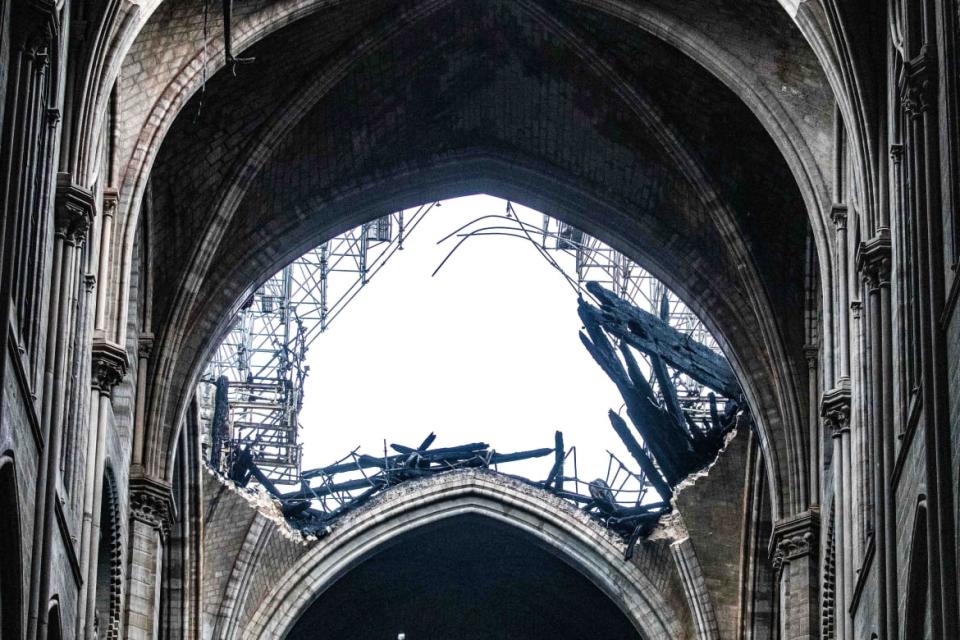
top-left (288, 516), bottom-right (639, 640)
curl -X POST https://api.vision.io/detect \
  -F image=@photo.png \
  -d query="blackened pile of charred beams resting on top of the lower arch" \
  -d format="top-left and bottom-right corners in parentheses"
top-left (216, 283), bottom-right (748, 557)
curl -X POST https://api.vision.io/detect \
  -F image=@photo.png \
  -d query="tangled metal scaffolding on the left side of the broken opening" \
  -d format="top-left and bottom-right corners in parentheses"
top-left (203, 203), bottom-right (436, 484)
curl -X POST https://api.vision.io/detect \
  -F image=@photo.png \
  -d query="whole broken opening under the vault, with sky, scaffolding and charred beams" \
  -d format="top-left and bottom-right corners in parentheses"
top-left (199, 196), bottom-right (747, 553)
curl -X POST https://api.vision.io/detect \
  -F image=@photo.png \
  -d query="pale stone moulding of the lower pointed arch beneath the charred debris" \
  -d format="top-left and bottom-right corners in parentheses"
top-left (241, 470), bottom-right (683, 638)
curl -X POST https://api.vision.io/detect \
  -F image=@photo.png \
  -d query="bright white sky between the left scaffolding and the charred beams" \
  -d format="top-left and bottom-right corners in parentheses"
top-left (300, 196), bottom-right (636, 480)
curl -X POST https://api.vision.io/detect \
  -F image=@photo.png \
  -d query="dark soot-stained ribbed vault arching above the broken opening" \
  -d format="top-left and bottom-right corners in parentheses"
top-left (131, 0), bottom-right (836, 524)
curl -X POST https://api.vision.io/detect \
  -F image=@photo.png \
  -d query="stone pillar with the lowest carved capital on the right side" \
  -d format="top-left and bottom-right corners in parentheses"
top-left (770, 509), bottom-right (820, 640)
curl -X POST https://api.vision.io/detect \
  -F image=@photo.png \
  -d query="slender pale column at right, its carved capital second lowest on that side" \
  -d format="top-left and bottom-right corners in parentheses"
top-left (820, 388), bottom-right (853, 640)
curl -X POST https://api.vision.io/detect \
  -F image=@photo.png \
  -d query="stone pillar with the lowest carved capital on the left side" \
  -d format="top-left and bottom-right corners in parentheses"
top-left (125, 476), bottom-right (173, 640)
